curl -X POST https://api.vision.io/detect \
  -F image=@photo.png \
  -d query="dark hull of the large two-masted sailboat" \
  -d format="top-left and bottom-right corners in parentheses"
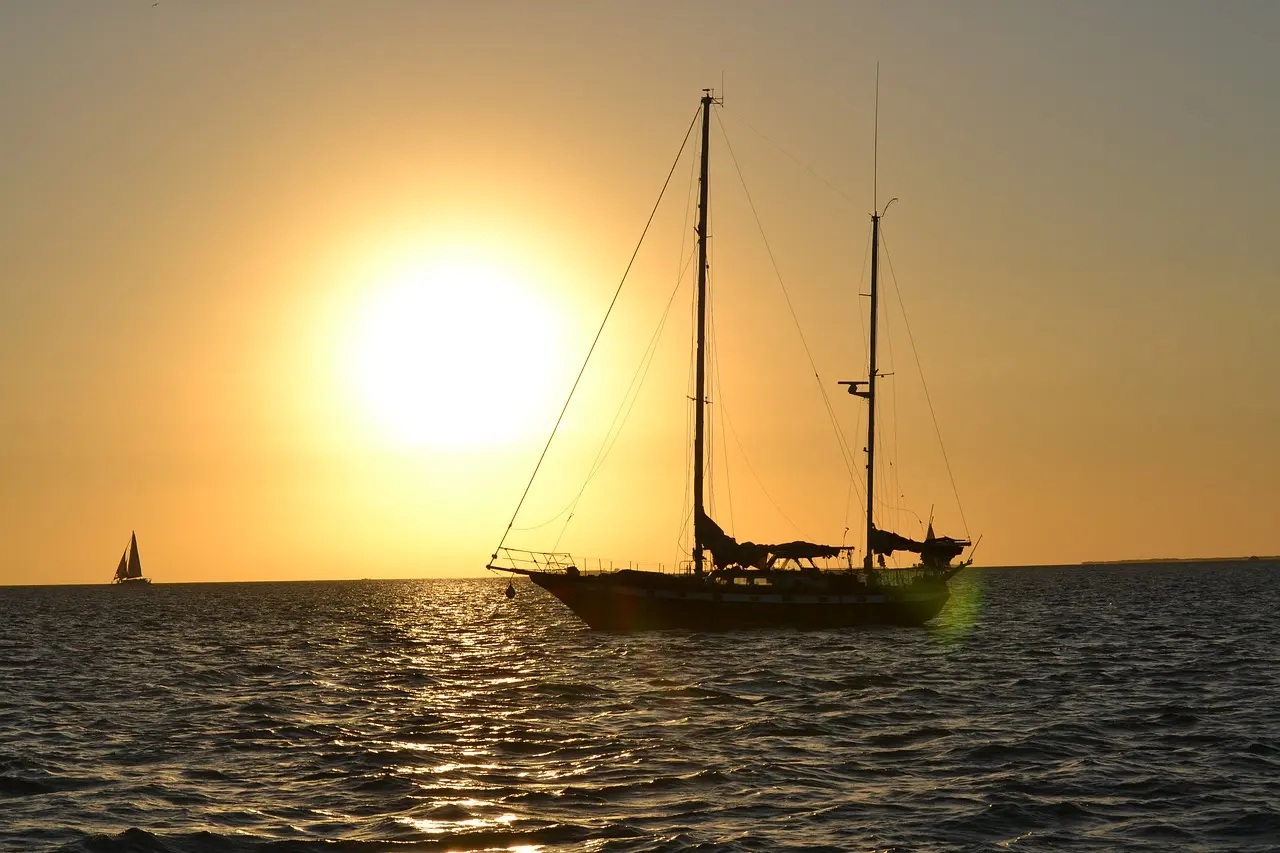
top-left (519, 573), bottom-right (950, 631)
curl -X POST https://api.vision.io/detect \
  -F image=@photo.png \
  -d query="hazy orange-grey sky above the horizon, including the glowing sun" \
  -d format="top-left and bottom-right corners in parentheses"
top-left (0, 0), bottom-right (1280, 583)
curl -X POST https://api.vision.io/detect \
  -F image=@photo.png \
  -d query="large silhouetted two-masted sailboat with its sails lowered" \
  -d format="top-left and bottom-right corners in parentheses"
top-left (486, 90), bottom-right (973, 631)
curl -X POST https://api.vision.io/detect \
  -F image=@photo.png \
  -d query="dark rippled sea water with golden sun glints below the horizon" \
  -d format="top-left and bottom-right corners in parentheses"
top-left (0, 562), bottom-right (1280, 853)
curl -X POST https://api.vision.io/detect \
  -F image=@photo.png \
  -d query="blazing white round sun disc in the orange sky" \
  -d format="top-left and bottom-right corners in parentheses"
top-left (349, 252), bottom-right (561, 450)
